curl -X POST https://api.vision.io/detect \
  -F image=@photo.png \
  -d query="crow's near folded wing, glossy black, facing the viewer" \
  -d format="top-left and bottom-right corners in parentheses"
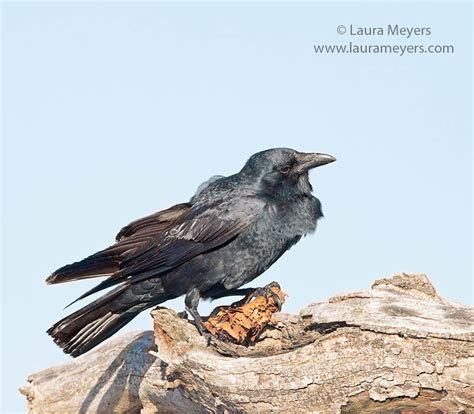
top-left (64, 197), bottom-right (264, 300)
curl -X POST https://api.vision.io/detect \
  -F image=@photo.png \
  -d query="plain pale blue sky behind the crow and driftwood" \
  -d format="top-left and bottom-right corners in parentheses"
top-left (1, 3), bottom-right (472, 411)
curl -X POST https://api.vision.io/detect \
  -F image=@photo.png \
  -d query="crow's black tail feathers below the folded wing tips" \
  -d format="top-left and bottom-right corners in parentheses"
top-left (47, 286), bottom-right (168, 357)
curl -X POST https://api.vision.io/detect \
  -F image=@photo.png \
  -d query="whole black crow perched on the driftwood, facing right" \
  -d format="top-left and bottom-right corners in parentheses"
top-left (46, 148), bottom-right (335, 357)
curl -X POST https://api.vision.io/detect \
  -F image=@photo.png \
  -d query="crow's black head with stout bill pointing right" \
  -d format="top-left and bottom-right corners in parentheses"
top-left (241, 148), bottom-right (336, 198)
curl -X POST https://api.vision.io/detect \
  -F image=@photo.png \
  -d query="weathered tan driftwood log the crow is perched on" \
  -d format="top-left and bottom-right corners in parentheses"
top-left (21, 274), bottom-right (474, 413)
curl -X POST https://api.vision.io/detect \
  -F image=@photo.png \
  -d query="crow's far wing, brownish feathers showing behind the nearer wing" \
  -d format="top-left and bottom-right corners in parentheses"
top-left (46, 203), bottom-right (191, 284)
